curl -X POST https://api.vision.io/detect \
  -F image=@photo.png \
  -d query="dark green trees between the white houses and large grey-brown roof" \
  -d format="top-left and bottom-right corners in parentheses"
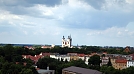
top-left (37, 57), bottom-right (88, 74)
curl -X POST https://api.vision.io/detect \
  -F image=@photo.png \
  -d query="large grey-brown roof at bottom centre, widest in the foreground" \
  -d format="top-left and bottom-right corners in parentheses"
top-left (63, 66), bottom-right (102, 74)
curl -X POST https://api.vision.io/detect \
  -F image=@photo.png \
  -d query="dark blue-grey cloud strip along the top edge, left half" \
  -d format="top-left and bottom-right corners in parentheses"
top-left (0, 0), bottom-right (62, 7)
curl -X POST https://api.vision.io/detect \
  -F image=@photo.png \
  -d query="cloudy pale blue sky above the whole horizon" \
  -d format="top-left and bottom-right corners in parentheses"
top-left (0, 0), bottom-right (134, 47)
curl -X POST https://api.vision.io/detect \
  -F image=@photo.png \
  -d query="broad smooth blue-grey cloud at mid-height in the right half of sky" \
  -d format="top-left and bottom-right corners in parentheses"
top-left (63, 7), bottom-right (134, 30)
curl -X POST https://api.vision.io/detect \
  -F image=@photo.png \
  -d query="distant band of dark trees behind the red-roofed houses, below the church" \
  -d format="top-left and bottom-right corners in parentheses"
top-left (33, 46), bottom-right (131, 55)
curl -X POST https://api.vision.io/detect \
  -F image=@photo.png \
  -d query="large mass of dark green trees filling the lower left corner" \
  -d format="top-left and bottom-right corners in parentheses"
top-left (0, 44), bottom-right (38, 74)
